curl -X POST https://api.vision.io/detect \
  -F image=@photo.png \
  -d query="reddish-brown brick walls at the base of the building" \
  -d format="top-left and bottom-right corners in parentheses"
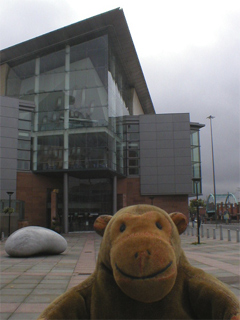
top-left (16, 172), bottom-right (188, 227)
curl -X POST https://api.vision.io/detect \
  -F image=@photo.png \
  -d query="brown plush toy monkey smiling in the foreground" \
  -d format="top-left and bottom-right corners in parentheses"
top-left (39, 205), bottom-right (240, 320)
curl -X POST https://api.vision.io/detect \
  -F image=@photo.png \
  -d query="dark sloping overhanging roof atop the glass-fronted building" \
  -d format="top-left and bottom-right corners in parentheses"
top-left (0, 8), bottom-right (155, 114)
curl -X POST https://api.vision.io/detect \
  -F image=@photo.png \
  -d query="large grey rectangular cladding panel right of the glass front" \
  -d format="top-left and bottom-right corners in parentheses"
top-left (139, 114), bottom-right (192, 195)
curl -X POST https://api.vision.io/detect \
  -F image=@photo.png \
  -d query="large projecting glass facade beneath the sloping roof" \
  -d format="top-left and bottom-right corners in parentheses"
top-left (7, 35), bottom-right (131, 174)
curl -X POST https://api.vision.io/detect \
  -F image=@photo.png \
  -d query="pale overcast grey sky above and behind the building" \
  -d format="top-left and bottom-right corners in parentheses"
top-left (0, 0), bottom-right (240, 199)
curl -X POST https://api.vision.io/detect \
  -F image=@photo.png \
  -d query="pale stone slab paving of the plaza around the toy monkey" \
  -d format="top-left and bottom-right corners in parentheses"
top-left (0, 232), bottom-right (240, 320)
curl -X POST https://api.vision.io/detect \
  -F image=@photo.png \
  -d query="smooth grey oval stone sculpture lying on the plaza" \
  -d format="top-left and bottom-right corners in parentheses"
top-left (5, 227), bottom-right (67, 257)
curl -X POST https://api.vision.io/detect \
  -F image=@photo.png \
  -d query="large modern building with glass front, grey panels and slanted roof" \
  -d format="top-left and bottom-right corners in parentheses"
top-left (0, 9), bottom-right (203, 232)
